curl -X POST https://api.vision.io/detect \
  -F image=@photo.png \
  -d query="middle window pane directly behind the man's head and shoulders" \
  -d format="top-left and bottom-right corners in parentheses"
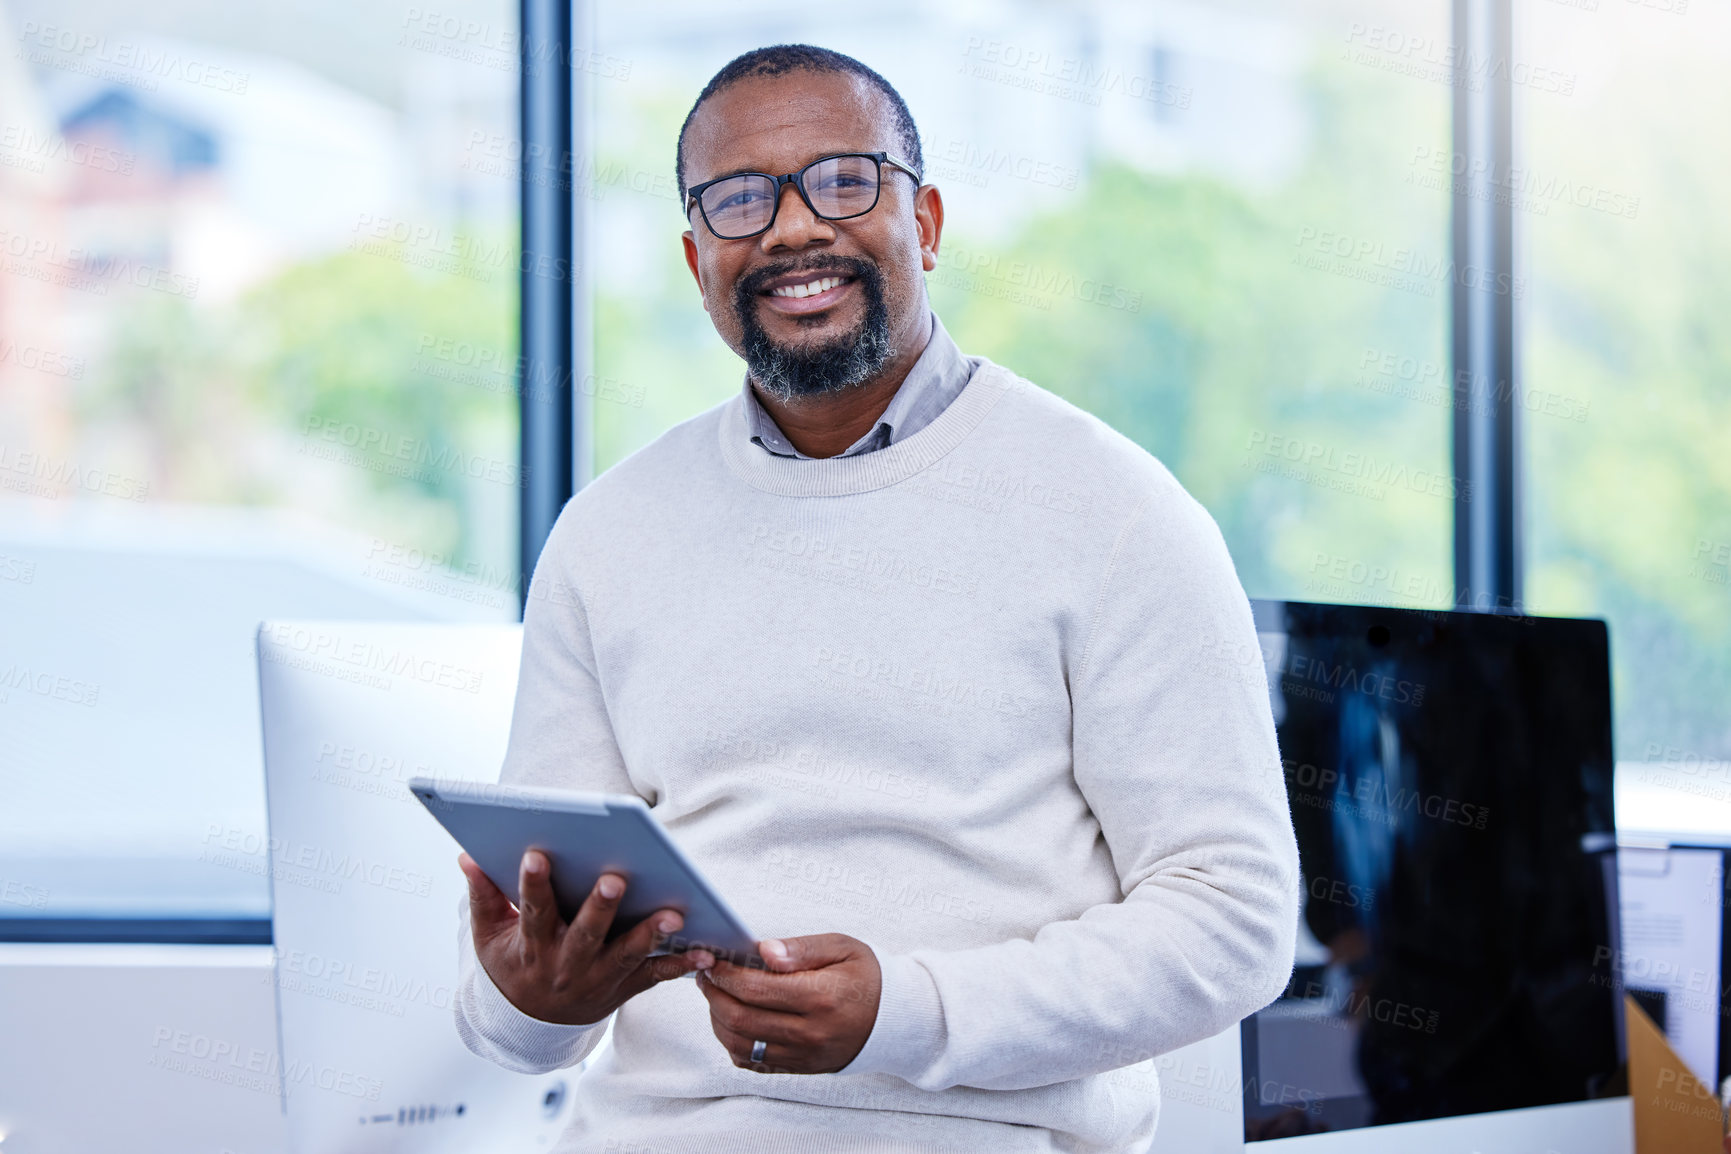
top-left (587, 0), bottom-right (1454, 606)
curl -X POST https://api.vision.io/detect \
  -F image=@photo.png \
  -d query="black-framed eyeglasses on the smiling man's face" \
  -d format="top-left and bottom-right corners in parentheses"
top-left (685, 152), bottom-right (919, 240)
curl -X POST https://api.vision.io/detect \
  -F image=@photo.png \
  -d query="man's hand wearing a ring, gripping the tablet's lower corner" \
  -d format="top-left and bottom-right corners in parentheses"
top-left (698, 934), bottom-right (883, 1074)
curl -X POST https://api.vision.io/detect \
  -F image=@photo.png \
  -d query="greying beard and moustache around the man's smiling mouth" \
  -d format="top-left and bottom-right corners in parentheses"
top-left (734, 258), bottom-right (895, 401)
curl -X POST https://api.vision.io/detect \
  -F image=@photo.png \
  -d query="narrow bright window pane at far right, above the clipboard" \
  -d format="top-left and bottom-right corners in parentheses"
top-left (1530, 0), bottom-right (1731, 768)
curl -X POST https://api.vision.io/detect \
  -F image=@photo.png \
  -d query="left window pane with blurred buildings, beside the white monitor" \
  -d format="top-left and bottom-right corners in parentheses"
top-left (0, 0), bottom-right (521, 917)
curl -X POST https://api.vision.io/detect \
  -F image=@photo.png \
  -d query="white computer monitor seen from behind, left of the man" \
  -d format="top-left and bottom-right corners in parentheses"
top-left (256, 621), bottom-right (576, 1154)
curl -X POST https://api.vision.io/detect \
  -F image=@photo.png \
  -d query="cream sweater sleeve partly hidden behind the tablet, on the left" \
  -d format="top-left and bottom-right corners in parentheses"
top-left (454, 507), bottom-right (634, 1073)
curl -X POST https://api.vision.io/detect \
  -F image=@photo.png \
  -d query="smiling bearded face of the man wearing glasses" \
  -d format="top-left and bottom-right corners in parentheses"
top-left (685, 71), bottom-right (943, 400)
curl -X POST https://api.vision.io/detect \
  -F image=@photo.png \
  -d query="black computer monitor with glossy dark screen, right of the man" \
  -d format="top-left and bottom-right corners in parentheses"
top-left (1243, 600), bottom-right (1627, 1140)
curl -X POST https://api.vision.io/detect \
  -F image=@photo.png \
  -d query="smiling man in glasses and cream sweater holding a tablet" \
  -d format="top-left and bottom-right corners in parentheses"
top-left (457, 45), bottom-right (1298, 1151)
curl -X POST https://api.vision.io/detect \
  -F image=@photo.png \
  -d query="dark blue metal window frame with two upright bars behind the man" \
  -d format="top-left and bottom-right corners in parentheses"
top-left (0, 0), bottom-right (1522, 945)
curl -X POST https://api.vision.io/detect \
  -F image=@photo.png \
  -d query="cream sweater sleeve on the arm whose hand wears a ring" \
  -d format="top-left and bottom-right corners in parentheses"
top-left (843, 481), bottom-right (1298, 1090)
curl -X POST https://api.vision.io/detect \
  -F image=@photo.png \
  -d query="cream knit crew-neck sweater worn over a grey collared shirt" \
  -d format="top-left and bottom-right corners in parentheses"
top-left (457, 363), bottom-right (1298, 1154)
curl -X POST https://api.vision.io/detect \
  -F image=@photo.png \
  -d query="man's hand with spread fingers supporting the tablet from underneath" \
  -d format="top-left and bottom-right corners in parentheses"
top-left (457, 849), bottom-right (716, 1024)
